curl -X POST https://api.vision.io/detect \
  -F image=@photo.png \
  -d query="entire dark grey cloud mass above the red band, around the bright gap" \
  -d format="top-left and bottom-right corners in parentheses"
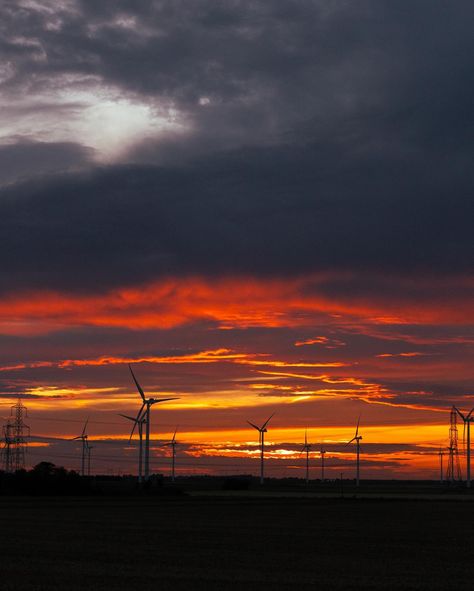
top-left (0, 1), bottom-right (474, 295)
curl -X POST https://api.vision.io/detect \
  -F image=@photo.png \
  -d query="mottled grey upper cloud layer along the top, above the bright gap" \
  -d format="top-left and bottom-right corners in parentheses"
top-left (2, 0), bottom-right (474, 154)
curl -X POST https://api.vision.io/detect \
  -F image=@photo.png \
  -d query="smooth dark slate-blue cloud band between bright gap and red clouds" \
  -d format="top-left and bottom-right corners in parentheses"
top-left (0, 154), bottom-right (474, 292)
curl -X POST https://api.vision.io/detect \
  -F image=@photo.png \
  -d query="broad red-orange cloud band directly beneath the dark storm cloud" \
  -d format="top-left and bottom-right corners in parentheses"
top-left (0, 274), bottom-right (473, 336)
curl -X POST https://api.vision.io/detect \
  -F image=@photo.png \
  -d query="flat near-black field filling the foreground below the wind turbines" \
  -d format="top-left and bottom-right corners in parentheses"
top-left (0, 497), bottom-right (474, 591)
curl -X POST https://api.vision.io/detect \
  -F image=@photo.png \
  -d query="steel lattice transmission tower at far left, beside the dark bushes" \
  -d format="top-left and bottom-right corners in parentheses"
top-left (2, 400), bottom-right (30, 472)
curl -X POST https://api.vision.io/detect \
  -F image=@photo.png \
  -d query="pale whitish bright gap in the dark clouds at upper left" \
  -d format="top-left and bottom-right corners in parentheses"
top-left (0, 76), bottom-right (189, 163)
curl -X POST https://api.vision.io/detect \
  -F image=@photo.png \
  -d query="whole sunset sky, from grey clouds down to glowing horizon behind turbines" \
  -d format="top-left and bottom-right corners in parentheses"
top-left (0, 0), bottom-right (474, 478)
